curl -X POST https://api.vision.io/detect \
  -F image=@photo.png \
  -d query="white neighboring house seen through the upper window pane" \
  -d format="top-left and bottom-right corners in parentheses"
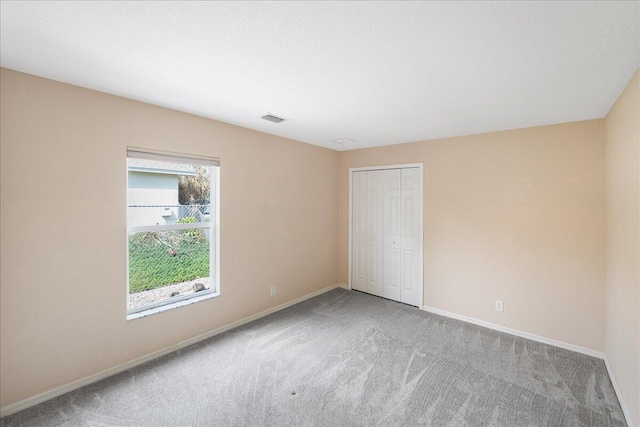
top-left (127, 159), bottom-right (196, 225)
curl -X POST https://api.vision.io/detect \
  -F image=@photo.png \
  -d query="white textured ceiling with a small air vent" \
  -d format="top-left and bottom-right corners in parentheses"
top-left (0, 1), bottom-right (640, 150)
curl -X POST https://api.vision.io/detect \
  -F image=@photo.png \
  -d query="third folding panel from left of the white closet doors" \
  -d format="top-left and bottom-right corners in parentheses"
top-left (382, 169), bottom-right (402, 301)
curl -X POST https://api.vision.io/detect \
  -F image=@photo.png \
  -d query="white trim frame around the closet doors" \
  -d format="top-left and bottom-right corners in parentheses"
top-left (347, 163), bottom-right (424, 308)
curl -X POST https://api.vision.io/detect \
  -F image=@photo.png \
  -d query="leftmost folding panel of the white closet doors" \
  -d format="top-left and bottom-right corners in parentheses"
top-left (351, 171), bottom-right (367, 291)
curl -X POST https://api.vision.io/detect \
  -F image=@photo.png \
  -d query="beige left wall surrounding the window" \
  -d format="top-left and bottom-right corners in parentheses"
top-left (0, 69), bottom-right (338, 407)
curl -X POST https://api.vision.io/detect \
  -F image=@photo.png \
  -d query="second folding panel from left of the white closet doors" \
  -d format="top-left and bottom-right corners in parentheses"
top-left (365, 171), bottom-right (383, 296)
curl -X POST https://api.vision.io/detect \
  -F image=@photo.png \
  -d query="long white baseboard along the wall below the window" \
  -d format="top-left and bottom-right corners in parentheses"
top-left (0, 284), bottom-right (340, 418)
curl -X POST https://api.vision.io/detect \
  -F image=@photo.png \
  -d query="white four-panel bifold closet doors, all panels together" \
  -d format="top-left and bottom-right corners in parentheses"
top-left (351, 167), bottom-right (422, 307)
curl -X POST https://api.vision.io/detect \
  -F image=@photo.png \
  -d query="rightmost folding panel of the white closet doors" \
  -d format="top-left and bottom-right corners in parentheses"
top-left (400, 168), bottom-right (423, 306)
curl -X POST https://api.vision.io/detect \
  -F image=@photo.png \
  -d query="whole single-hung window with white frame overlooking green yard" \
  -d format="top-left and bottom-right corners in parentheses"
top-left (127, 148), bottom-right (220, 319)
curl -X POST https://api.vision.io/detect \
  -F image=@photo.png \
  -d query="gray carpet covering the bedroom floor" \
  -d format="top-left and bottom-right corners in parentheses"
top-left (0, 289), bottom-right (625, 427)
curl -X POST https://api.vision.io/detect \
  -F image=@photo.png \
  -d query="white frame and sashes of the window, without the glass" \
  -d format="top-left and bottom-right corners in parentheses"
top-left (126, 147), bottom-right (220, 320)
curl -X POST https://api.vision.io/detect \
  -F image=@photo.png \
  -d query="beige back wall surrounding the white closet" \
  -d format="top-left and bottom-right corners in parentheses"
top-left (339, 120), bottom-right (605, 351)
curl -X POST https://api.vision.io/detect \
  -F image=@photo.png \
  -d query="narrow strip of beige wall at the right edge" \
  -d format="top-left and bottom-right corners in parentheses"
top-left (605, 68), bottom-right (640, 425)
